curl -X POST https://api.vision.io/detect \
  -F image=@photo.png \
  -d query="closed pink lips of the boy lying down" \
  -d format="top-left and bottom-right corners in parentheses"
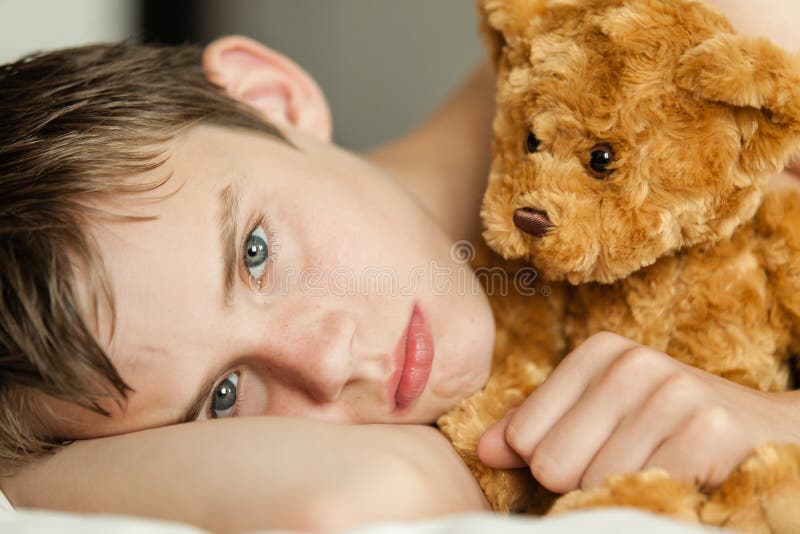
top-left (388, 303), bottom-right (433, 412)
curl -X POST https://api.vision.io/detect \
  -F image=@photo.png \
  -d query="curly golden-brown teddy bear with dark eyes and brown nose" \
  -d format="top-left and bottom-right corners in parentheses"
top-left (437, 0), bottom-right (800, 532)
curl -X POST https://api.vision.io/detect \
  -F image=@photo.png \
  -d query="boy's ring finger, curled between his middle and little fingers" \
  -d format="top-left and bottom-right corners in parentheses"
top-left (580, 375), bottom-right (699, 489)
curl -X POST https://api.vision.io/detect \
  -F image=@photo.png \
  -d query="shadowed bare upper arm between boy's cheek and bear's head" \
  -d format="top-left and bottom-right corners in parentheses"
top-left (365, 62), bottom-right (495, 245)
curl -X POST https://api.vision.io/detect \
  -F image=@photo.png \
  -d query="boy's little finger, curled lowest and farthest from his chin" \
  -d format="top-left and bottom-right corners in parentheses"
top-left (645, 407), bottom-right (750, 487)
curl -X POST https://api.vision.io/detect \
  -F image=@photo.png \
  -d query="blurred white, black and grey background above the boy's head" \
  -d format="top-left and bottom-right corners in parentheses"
top-left (0, 0), bottom-right (483, 149)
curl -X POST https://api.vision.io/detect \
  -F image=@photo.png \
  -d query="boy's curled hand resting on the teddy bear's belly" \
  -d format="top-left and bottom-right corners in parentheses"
top-left (478, 332), bottom-right (798, 493)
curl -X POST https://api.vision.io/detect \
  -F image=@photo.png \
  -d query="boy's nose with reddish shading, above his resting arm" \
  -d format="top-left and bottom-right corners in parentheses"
top-left (267, 311), bottom-right (355, 403)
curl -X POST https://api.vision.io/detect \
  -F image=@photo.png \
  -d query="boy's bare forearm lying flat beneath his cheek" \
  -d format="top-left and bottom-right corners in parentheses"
top-left (0, 417), bottom-right (487, 532)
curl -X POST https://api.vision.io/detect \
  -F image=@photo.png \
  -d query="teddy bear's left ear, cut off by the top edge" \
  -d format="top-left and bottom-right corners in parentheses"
top-left (477, 0), bottom-right (547, 65)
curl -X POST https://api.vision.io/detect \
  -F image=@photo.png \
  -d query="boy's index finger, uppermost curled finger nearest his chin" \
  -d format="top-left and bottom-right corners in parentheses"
top-left (506, 340), bottom-right (650, 459)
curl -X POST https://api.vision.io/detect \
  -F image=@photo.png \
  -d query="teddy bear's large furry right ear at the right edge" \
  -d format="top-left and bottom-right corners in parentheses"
top-left (675, 33), bottom-right (800, 172)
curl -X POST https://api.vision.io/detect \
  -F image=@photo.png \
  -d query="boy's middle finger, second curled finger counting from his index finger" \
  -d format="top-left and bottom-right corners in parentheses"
top-left (529, 349), bottom-right (666, 493)
